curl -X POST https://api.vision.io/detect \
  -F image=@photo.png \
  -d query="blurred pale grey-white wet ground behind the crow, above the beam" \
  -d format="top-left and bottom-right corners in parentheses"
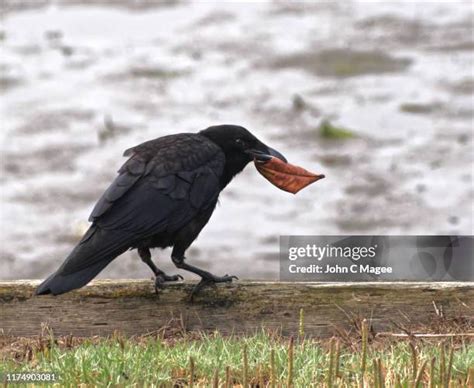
top-left (0, 0), bottom-right (474, 279)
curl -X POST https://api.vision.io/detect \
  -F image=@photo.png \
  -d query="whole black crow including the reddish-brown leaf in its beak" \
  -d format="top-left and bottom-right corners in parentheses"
top-left (36, 125), bottom-right (324, 296)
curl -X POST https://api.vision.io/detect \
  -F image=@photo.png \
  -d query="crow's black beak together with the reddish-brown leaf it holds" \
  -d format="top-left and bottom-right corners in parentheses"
top-left (250, 147), bottom-right (324, 194)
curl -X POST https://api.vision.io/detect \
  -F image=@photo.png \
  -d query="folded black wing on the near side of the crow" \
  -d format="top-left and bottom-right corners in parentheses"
top-left (62, 134), bottom-right (225, 274)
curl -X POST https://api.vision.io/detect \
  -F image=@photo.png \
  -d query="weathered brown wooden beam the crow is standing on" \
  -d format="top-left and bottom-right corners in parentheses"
top-left (0, 280), bottom-right (474, 336)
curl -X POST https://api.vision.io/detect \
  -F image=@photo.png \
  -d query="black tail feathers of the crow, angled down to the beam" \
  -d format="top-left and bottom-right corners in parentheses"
top-left (36, 225), bottom-right (130, 295)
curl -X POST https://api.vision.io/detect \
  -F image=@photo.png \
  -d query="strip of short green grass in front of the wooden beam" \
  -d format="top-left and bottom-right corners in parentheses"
top-left (0, 331), bottom-right (474, 387)
